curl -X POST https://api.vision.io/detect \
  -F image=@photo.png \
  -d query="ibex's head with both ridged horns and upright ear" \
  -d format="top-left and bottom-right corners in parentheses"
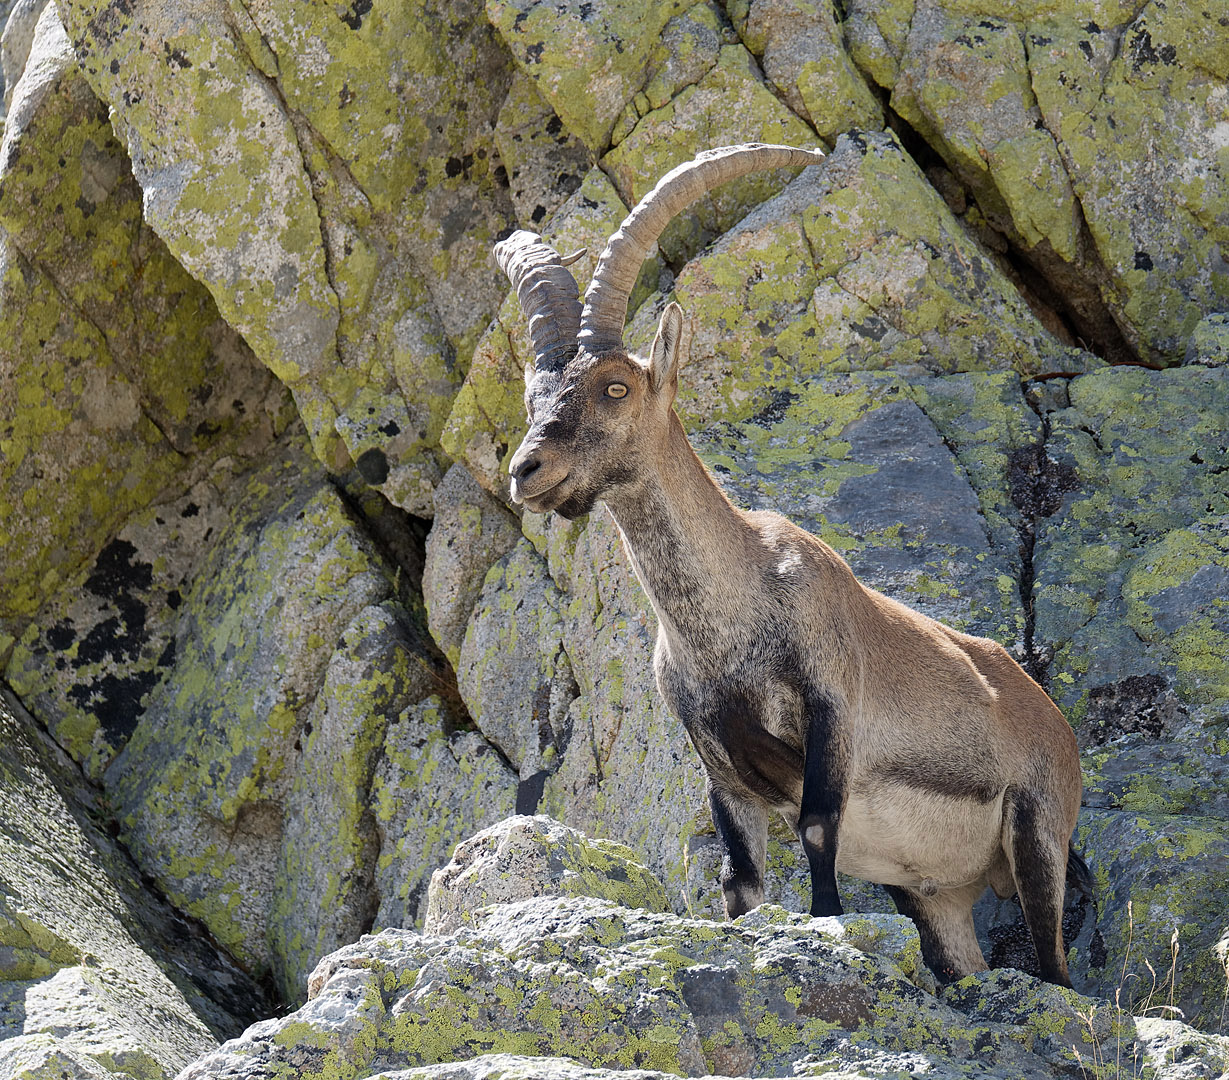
top-left (495, 144), bottom-right (823, 518)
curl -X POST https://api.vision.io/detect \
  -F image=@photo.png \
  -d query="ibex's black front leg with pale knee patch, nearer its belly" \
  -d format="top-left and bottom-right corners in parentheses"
top-left (798, 697), bottom-right (846, 915)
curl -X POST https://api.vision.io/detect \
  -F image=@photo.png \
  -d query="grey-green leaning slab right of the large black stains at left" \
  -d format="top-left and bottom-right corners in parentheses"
top-left (106, 442), bottom-right (393, 968)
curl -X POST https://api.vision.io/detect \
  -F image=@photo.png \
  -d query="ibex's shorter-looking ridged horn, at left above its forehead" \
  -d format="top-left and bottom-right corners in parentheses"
top-left (495, 230), bottom-right (584, 371)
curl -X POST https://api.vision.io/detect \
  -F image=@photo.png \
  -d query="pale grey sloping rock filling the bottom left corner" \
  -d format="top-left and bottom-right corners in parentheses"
top-left (0, 689), bottom-right (267, 1080)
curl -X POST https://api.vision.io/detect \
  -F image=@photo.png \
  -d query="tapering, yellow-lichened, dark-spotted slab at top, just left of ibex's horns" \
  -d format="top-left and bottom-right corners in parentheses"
top-left (252, 2), bottom-right (512, 515)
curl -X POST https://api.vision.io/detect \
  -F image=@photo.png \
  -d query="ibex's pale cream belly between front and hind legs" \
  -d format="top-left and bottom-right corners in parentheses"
top-left (837, 784), bottom-right (1003, 890)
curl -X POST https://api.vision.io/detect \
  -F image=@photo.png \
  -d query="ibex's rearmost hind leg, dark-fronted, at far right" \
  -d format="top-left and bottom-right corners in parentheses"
top-left (1003, 789), bottom-right (1072, 987)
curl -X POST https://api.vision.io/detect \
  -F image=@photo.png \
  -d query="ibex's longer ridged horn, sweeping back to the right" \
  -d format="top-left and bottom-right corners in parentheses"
top-left (579, 143), bottom-right (823, 353)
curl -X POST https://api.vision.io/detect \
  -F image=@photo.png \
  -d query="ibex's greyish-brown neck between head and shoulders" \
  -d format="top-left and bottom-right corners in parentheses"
top-left (606, 415), bottom-right (755, 646)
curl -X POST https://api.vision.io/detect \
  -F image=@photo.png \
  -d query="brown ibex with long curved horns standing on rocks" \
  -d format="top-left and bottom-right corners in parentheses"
top-left (495, 145), bottom-right (1089, 987)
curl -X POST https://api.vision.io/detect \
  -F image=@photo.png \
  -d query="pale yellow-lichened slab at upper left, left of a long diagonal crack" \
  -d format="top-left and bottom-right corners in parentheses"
top-left (64, 0), bottom-right (338, 393)
